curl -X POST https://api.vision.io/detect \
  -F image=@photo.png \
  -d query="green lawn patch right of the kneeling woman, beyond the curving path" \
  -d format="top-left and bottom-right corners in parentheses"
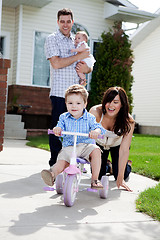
top-left (129, 134), bottom-right (160, 181)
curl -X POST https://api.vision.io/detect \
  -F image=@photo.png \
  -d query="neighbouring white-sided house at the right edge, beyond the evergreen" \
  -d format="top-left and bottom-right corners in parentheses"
top-left (131, 10), bottom-right (160, 135)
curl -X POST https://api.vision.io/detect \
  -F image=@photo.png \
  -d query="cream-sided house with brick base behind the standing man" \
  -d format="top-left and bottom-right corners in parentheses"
top-left (0, 0), bottom-right (156, 135)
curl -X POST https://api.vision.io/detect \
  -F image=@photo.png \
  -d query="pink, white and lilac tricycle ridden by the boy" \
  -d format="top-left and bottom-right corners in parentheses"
top-left (48, 130), bottom-right (109, 207)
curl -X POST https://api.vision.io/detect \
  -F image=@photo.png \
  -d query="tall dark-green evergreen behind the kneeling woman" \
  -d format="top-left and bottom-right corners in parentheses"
top-left (89, 22), bottom-right (133, 112)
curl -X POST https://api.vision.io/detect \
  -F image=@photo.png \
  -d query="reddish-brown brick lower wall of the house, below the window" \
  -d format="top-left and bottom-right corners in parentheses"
top-left (7, 85), bottom-right (51, 115)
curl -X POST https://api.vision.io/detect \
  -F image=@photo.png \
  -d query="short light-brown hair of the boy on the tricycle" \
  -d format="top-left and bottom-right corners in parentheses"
top-left (65, 84), bottom-right (88, 103)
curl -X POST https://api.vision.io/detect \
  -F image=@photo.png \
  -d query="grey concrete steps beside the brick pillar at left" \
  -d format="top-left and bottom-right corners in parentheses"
top-left (4, 114), bottom-right (27, 139)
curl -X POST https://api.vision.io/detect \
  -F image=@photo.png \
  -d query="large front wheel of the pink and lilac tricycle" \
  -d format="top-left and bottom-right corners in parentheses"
top-left (63, 174), bottom-right (78, 207)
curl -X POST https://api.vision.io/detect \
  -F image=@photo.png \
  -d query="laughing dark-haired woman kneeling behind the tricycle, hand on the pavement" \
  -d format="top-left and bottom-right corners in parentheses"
top-left (89, 87), bottom-right (134, 191)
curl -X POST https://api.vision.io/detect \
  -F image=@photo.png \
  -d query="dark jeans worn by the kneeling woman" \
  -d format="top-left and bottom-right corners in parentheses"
top-left (97, 144), bottom-right (131, 180)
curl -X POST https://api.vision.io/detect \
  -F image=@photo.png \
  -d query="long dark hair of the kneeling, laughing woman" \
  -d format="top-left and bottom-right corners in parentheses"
top-left (102, 87), bottom-right (134, 136)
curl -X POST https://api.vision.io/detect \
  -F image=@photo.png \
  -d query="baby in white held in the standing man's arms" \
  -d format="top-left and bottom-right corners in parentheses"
top-left (71, 31), bottom-right (96, 86)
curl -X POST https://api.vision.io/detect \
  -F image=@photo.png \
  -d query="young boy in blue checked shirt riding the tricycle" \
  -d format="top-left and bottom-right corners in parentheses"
top-left (41, 84), bottom-right (106, 189)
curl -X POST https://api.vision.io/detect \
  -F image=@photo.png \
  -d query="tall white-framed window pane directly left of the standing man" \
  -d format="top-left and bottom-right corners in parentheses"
top-left (33, 32), bottom-right (50, 86)
